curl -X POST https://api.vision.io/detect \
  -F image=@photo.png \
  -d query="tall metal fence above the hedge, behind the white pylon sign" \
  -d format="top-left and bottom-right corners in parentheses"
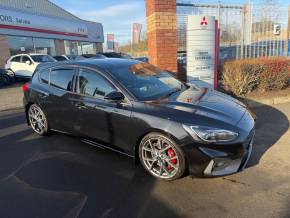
top-left (177, 1), bottom-right (289, 61)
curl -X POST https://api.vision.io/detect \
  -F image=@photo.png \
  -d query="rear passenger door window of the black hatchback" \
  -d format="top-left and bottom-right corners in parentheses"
top-left (50, 68), bottom-right (75, 91)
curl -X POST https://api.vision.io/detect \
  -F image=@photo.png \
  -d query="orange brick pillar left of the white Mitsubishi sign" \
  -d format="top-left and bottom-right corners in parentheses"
top-left (146, 0), bottom-right (178, 73)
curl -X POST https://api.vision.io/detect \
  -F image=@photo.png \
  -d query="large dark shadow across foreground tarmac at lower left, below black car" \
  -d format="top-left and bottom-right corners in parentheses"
top-left (0, 110), bottom-right (178, 218)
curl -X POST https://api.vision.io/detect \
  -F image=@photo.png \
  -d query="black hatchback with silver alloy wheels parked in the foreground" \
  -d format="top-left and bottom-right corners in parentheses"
top-left (23, 59), bottom-right (255, 180)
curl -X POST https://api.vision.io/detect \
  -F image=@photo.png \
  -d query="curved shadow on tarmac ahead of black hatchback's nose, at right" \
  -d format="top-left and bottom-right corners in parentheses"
top-left (247, 100), bottom-right (289, 168)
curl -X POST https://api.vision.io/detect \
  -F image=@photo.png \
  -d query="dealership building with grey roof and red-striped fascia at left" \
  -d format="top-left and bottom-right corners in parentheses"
top-left (0, 0), bottom-right (104, 67)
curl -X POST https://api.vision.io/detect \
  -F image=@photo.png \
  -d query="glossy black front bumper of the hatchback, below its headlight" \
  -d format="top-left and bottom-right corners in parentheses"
top-left (184, 130), bottom-right (254, 178)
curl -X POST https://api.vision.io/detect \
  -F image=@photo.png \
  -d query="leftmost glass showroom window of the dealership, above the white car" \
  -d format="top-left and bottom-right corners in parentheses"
top-left (8, 36), bottom-right (34, 55)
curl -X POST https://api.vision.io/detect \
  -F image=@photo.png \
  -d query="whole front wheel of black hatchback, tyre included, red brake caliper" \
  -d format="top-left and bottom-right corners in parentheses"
top-left (139, 133), bottom-right (186, 181)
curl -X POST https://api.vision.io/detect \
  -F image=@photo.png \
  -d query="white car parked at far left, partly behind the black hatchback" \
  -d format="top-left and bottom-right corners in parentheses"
top-left (5, 54), bottom-right (56, 78)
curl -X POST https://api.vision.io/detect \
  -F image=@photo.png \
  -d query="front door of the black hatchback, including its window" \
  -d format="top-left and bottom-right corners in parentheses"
top-left (73, 68), bottom-right (131, 150)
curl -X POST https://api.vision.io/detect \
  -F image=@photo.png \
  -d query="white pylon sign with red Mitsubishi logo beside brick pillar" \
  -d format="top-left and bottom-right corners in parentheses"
top-left (187, 15), bottom-right (217, 86)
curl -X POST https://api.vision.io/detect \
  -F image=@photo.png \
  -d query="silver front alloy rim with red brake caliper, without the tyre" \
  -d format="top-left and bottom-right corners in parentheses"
top-left (141, 136), bottom-right (179, 179)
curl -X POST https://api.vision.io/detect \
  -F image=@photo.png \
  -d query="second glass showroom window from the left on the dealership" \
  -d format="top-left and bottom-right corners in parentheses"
top-left (33, 38), bottom-right (56, 56)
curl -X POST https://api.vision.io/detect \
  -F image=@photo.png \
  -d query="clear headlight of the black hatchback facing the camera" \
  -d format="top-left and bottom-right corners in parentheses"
top-left (182, 124), bottom-right (239, 142)
